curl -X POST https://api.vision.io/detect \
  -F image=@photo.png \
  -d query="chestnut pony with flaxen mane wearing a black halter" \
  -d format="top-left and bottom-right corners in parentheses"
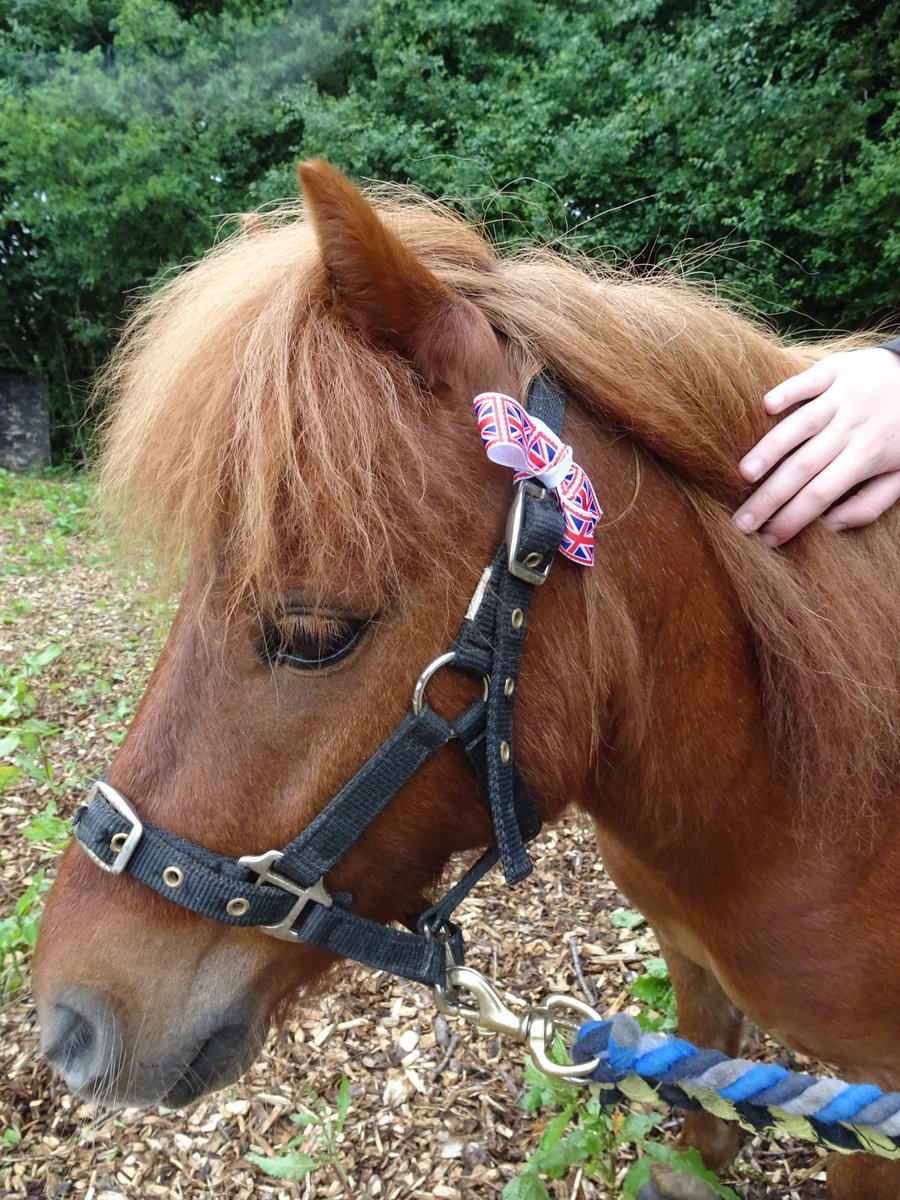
top-left (35, 162), bottom-right (900, 1200)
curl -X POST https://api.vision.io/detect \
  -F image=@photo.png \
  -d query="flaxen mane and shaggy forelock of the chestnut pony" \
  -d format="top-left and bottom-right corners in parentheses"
top-left (100, 188), bottom-right (900, 814)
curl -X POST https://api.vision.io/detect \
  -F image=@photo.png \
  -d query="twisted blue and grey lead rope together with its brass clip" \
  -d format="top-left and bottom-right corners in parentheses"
top-left (434, 965), bottom-right (900, 1158)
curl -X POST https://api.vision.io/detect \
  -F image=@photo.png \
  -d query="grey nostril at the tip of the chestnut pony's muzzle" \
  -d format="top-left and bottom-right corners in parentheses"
top-left (41, 989), bottom-right (119, 1092)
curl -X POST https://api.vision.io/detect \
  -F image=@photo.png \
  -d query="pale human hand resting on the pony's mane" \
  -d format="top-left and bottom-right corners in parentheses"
top-left (732, 348), bottom-right (900, 546)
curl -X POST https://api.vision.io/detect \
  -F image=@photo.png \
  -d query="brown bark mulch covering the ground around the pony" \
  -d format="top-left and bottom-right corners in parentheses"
top-left (0, 482), bottom-right (824, 1200)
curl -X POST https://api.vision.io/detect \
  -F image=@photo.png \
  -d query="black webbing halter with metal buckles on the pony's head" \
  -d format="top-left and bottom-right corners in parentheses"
top-left (74, 376), bottom-right (565, 986)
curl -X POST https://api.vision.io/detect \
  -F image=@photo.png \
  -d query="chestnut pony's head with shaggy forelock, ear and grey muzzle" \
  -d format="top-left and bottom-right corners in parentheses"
top-left (35, 162), bottom-right (595, 1104)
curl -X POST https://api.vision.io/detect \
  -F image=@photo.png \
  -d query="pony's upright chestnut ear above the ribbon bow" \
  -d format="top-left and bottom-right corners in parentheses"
top-left (298, 158), bottom-right (502, 390)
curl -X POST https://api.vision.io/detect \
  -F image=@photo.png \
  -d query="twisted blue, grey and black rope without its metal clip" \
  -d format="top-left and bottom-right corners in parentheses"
top-left (572, 1013), bottom-right (900, 1157)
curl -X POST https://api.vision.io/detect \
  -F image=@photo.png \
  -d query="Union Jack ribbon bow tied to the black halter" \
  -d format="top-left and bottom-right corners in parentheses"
top-left (473, 391), bottom-right (604, 566)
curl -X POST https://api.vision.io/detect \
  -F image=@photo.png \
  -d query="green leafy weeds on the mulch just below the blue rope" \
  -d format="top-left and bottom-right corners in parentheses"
top-left (503, 1061), bottom-right (738, 1200)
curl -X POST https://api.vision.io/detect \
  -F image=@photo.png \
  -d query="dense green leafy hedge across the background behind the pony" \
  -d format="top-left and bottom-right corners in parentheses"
top-left (0, 0), bottom-right (900, 451)
